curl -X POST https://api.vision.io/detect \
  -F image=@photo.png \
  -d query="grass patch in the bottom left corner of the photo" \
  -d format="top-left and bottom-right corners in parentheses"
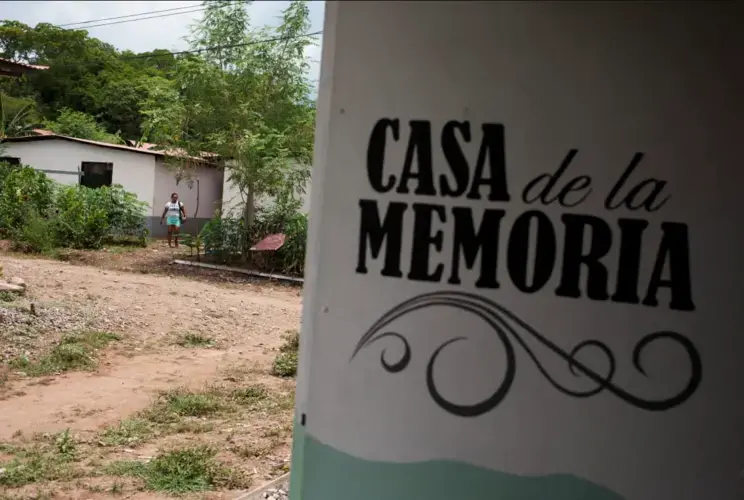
top-left (0, 430), bottom-right (80, 487)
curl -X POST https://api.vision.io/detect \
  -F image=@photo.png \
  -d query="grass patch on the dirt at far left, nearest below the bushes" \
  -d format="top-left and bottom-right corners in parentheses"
top-left (10, 332), bottom-right (120, 377)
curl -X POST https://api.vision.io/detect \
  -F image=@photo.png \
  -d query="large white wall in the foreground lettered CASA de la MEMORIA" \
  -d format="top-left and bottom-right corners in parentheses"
top-left (292, 2), bottom-right (744, 500)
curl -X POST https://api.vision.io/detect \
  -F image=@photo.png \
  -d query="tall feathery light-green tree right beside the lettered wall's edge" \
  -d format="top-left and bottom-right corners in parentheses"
top-left (145, 0), bottom-right (315, 248)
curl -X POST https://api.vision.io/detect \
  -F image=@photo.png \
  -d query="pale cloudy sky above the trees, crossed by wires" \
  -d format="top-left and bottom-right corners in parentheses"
top-left (0, 0), bottom-right (325, 84)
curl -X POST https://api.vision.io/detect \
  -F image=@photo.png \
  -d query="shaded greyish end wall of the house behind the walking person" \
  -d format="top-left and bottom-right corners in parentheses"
top-left (152, 158), bottom-right (224, 219)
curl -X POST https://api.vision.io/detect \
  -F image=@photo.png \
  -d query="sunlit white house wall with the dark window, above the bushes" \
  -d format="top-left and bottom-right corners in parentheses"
top-left (4, 139), bottom-right (156, 212)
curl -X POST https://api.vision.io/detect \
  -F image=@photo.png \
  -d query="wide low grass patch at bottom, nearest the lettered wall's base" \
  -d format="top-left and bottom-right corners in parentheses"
top-left (106, 446), bottom-right (250, 494)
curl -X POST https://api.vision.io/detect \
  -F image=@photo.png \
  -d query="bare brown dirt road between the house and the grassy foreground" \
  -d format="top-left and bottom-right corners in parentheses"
top-left (0, 252), bottom-right (301, 497)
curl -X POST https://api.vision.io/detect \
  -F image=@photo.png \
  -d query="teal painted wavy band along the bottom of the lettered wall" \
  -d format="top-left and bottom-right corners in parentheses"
top-left (290, 425), bottom-right (624, 500)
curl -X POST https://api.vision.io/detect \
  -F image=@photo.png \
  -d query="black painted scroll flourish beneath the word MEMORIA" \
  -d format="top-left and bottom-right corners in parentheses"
top-left (350, 291), bottom-right (702, 417)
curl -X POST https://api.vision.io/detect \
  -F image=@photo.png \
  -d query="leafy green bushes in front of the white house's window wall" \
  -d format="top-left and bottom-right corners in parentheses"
top-left (0, 164), bottom-right (147, 252)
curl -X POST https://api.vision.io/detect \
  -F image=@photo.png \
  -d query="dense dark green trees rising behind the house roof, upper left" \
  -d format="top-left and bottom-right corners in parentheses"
top-left (0, 21), bottom-right (183, 139)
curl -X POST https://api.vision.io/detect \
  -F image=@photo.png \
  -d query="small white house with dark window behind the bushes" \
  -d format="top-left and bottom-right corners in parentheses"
top-left (0, 131), bottom-right (224, 236)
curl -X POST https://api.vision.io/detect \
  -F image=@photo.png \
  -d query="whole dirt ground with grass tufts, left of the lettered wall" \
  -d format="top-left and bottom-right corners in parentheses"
top-left (0, 242), bottom-right (301, 499)
